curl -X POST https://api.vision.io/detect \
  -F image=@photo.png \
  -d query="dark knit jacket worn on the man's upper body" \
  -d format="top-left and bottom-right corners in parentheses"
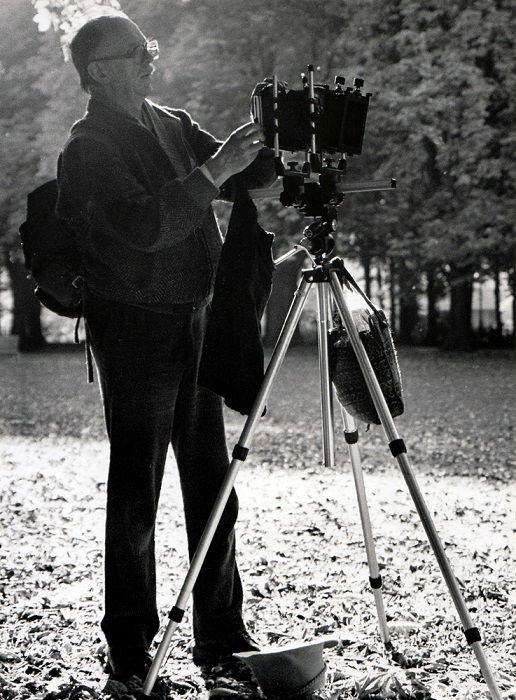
top-left (56, 98), bottom-right (222, 310)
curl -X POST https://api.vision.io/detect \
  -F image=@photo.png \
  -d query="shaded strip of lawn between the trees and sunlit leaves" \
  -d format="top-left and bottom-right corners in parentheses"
top-left (0, 346), bottom-right (516, 480)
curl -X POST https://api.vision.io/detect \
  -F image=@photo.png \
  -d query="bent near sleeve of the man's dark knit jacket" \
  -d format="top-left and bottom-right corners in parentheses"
top-left (56, 134), bottom-right (219, 252)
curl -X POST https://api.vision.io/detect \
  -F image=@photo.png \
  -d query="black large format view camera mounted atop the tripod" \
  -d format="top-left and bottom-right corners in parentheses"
top-left (250, 64), bottom-right (396, 255)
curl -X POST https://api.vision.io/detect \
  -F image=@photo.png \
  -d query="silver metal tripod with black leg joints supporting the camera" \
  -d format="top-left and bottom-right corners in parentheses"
top-left (143, 227), bottom-right (501, 700)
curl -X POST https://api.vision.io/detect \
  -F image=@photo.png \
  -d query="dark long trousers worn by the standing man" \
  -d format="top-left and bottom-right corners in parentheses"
top-left (85, 297), bottom-right (244, 649)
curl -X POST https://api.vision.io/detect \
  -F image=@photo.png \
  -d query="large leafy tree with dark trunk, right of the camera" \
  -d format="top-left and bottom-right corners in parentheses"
top-left (360, 0), bottom-right (514, 347)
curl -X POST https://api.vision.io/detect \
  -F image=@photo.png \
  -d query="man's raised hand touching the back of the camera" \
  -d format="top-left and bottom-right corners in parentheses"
top-left (204, 122), bottom-right (264, 187)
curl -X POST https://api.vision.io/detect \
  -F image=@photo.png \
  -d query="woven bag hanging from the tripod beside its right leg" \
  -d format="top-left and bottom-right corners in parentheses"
top-left (328, 268), bottom-right (404, 425)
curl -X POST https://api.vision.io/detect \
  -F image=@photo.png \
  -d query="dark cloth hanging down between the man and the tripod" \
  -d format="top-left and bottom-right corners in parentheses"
top-left (198, 191), bottom-right (274, 415)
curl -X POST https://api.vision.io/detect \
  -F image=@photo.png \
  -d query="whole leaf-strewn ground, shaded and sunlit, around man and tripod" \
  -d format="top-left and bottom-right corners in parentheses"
top-left (0, 348), bottom-right (516, 700)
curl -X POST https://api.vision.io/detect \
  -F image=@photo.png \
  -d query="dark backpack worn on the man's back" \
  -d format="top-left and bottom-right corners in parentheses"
top-left (19, 180), bottom-right (82, 318)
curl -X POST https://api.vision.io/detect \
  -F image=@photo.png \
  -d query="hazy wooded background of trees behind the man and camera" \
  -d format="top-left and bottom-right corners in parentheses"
top-left (0, 0), bottom-right (516, 350)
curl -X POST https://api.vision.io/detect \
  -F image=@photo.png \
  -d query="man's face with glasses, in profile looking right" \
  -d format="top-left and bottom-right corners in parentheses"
top-left (90, 18), bottom-right (154, 97)
